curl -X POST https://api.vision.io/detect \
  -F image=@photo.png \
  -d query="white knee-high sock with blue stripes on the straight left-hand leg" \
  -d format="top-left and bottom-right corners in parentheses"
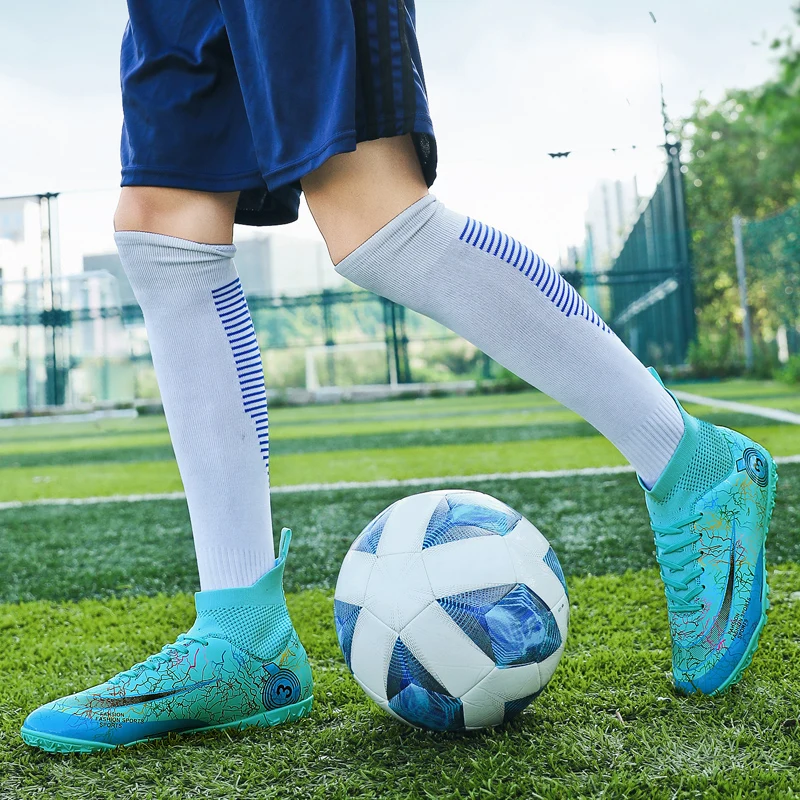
top-left (116, 231), bottom-right (275, 590)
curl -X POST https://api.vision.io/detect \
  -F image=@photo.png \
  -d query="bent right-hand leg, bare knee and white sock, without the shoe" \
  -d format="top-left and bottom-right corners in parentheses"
top-left (303, 137), bottom-right (683, 485)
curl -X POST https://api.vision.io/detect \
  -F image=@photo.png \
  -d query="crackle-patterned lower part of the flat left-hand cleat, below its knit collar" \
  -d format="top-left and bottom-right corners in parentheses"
top-left (21, 636), bottom-right (312, 752)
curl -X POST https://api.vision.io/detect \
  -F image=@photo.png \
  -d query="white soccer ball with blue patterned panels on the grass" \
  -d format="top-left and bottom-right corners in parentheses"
top-left (334, 490), bottom-right (569, 731)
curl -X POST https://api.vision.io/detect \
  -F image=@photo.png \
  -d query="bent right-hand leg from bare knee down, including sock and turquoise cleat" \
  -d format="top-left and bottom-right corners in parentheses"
top-left (305, 139), bottom-right (777, 694)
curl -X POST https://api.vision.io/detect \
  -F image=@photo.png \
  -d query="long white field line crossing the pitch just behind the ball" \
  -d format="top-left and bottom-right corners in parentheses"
top-left (0, 454), bottom-right (800, 511)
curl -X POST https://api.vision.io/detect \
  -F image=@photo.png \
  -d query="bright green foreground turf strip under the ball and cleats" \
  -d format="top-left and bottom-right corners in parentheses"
top-left (0, 559), bottom-right (800, 800)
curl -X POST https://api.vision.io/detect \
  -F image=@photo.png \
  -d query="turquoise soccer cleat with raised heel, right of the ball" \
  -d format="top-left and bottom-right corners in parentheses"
top-left (645, 370), bottom-right (778, 695)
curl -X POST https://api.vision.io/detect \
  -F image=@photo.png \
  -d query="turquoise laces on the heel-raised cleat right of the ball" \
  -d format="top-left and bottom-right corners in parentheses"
top-left (651, 514), bottom-right (703, 612)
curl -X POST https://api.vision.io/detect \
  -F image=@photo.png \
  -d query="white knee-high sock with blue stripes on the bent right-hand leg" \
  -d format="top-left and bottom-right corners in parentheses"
top-left (336, 195), bottom-right (683, 486)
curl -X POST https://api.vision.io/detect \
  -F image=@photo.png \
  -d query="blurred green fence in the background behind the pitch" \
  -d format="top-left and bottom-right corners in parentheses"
top-left (0, 171), bottom-right (800, 414)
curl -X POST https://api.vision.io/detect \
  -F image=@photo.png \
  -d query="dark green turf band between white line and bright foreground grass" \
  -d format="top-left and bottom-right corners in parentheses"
top-left (0, 464), bottom-right (800, 602)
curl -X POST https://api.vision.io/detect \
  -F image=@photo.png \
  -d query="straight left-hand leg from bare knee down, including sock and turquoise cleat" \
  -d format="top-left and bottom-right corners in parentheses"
top-left (21, 187), bottom-right (312, 752)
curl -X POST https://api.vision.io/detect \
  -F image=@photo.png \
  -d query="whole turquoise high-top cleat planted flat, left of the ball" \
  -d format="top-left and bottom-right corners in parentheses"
top-left (21, 529), bottom-right (312, 753)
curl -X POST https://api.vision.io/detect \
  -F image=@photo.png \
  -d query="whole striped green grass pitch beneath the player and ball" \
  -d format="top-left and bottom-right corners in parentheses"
top-left (0, 381), bottom-right (800, 800)
